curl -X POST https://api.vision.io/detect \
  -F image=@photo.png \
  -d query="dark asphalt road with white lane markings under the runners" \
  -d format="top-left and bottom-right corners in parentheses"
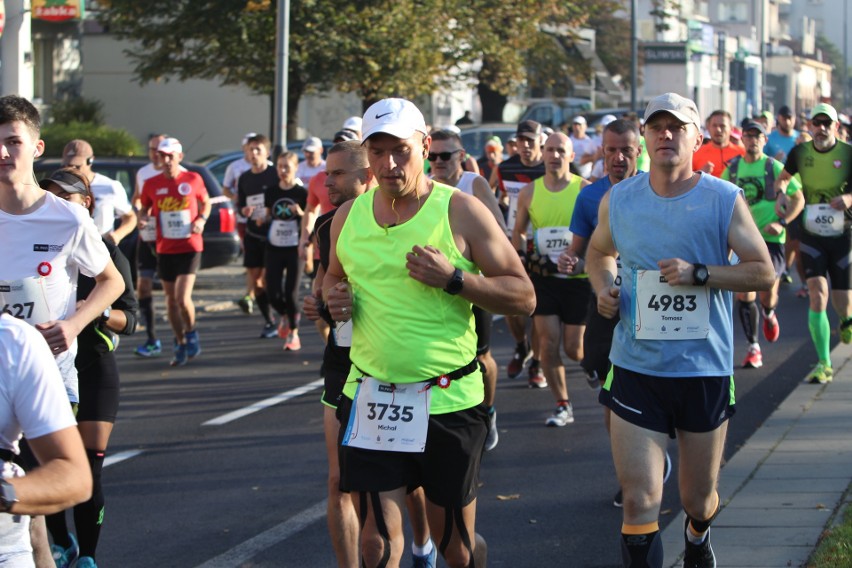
top-left (83, 267), bottom-right (815, 568)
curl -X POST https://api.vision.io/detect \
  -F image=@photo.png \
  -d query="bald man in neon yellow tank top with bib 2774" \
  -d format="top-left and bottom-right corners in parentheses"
top-left (512, 133), bottom-right (591, 427)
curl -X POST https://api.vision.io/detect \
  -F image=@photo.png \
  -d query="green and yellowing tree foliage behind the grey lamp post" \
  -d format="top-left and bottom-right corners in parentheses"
top-left (98, 0), bottom-right (618, 127)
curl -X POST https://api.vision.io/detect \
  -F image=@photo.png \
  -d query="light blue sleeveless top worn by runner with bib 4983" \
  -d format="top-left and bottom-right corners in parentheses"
top-left (610, 174), bottom-right (742, 377)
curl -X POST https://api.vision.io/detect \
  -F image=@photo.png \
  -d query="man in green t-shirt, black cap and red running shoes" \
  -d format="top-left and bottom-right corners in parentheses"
top-left (722, 122), bottom-right (803, 369)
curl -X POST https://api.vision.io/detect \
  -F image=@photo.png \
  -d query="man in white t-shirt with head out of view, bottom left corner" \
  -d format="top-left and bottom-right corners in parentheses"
top-left (0, 314), bottom-right (92, 567)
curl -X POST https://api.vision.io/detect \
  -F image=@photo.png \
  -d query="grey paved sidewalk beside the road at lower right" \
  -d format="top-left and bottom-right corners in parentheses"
top-left (662, 344), bottom-right (852, 568)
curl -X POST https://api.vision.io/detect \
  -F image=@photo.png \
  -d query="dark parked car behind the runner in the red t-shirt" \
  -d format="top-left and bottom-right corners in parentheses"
top-left (34, 157), bottom-right (240, 268)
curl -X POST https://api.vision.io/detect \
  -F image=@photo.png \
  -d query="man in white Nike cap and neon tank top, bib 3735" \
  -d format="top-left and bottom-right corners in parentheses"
top-left (323, 99), bottom-right (535, 567)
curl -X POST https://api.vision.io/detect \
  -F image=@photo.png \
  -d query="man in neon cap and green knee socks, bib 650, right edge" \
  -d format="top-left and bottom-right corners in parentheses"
top-left (775, 103), bottom-right (852, 384)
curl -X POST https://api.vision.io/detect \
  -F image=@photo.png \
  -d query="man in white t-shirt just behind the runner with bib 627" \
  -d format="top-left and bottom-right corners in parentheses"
top-left (62, 140), bottom-right (136, 245)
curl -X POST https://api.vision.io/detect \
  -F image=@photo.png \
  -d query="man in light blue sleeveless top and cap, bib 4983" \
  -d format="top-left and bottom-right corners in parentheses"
top-left (586, 93), bottom-right (775, 568)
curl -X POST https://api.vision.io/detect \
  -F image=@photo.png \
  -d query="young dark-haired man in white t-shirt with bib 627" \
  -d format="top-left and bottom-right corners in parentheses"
top-left (0, 95), bottom-right (124, 403)
